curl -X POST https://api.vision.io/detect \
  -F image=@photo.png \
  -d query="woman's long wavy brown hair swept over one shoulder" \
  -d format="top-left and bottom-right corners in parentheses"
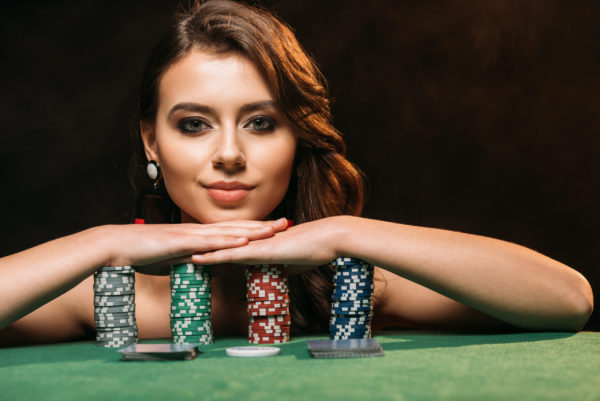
top-left (132, 0), bottom-right (365, 333)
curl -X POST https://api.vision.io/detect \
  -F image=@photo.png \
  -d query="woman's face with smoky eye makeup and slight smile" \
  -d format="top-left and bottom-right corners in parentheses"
top-left (142, 50), bottom-right (296, 223)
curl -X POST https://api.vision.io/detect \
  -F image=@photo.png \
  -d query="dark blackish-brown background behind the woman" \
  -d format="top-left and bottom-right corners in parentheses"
top-left (0, 0), bottom-right (600, 330)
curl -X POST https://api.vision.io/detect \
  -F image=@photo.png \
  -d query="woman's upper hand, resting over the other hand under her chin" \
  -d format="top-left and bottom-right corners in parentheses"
top-left (107, 219), bottom-right (287, 275)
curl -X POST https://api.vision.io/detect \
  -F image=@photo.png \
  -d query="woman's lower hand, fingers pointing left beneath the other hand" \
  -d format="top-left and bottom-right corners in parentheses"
top-left (192, 216), bottom-right (345, 274)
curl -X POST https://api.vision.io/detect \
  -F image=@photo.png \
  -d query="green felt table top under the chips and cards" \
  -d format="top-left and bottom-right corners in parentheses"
top-left (0, 332), bottom-right (600, 401)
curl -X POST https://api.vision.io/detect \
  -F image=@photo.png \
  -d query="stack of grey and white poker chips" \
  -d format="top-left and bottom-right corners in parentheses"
top-left (94, 266), bottom-right (138, 347)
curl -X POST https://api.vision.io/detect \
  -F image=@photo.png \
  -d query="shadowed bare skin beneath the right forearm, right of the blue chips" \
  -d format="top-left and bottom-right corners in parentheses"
top-left (373, 267), bottom-right (509, 330)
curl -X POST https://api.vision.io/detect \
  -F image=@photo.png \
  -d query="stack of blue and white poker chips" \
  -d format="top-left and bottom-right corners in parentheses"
top-left (329, 258), bottom-right (374, 340)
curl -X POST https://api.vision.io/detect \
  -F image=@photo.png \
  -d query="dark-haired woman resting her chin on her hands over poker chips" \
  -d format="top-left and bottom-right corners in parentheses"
top-left (0, 1), bottom-right (593, 344)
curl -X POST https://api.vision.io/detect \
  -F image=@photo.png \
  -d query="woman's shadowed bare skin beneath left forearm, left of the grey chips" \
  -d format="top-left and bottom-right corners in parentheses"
top-left (0, 276), bottom-right (94, 346)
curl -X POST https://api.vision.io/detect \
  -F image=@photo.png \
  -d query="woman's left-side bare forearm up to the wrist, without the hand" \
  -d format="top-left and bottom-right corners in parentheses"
top-left (0, 227), bottom-right (109, 329)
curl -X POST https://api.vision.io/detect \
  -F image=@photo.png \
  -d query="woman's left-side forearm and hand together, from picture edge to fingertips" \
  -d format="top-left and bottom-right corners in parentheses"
top-left (0, 219), bottom-right (287, 329)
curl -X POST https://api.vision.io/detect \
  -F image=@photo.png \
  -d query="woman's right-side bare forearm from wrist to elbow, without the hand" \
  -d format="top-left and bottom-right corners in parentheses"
top-left (338, 217), bottom-right (593, 330)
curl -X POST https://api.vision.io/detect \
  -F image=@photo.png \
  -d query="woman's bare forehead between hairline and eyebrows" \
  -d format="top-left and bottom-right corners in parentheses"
top-left (159, 50), bottom-right (272, 109)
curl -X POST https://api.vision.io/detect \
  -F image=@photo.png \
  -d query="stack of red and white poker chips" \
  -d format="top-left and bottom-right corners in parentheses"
top-left (246, 265), bottom-right (291, 344)
